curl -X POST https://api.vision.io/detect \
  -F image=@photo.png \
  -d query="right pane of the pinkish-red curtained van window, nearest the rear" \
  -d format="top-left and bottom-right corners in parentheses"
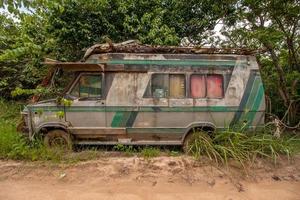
top-left (206, 75), bottom-right (223, 98)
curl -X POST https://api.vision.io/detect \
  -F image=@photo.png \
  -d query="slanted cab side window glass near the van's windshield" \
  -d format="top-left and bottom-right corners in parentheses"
top-left (70, 74), bottom-right (102, 97)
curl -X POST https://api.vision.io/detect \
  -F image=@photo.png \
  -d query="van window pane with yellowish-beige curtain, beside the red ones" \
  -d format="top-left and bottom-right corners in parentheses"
top-left (169, 74), bottom-right (185, 98)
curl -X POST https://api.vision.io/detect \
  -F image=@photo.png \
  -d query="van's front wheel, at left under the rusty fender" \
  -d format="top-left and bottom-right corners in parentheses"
top-left (44, 129), bottom-right (72, 150)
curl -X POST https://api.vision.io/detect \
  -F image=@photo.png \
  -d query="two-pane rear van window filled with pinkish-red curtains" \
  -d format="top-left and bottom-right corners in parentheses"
top-left (190, 74), bottom-right (224, 98)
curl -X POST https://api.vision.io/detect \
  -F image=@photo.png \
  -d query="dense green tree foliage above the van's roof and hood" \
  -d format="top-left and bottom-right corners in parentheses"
top-left (0, 0), bottom-right (233, 99)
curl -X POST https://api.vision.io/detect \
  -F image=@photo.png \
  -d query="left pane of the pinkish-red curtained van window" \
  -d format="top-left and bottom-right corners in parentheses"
top-left (191, 75), bottom-right (205, 98)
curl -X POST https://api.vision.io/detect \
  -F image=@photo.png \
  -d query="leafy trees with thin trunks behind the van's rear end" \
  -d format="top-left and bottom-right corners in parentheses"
top-left (221, 0), bottom-right (300, 124)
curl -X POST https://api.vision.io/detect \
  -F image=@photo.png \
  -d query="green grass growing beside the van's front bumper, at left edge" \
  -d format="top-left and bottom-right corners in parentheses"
top-left (0, 99), bottom-right (68, 162)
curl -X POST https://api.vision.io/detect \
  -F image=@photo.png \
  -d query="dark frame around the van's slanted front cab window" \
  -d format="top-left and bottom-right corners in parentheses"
top-left (66, 72), bottom-right (105, 100)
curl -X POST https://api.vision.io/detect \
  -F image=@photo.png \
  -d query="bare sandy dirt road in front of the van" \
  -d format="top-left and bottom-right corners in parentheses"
top-left (0, 156), bottom-right (300, 200)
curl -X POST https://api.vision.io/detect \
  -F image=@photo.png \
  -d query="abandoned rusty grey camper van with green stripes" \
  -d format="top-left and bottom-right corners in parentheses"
top-left (22, 43), bottom-right (265, 146)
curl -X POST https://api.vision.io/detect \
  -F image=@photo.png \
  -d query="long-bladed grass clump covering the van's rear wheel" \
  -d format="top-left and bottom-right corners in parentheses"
top-left (188, 129), bottom-right (298, 166)
